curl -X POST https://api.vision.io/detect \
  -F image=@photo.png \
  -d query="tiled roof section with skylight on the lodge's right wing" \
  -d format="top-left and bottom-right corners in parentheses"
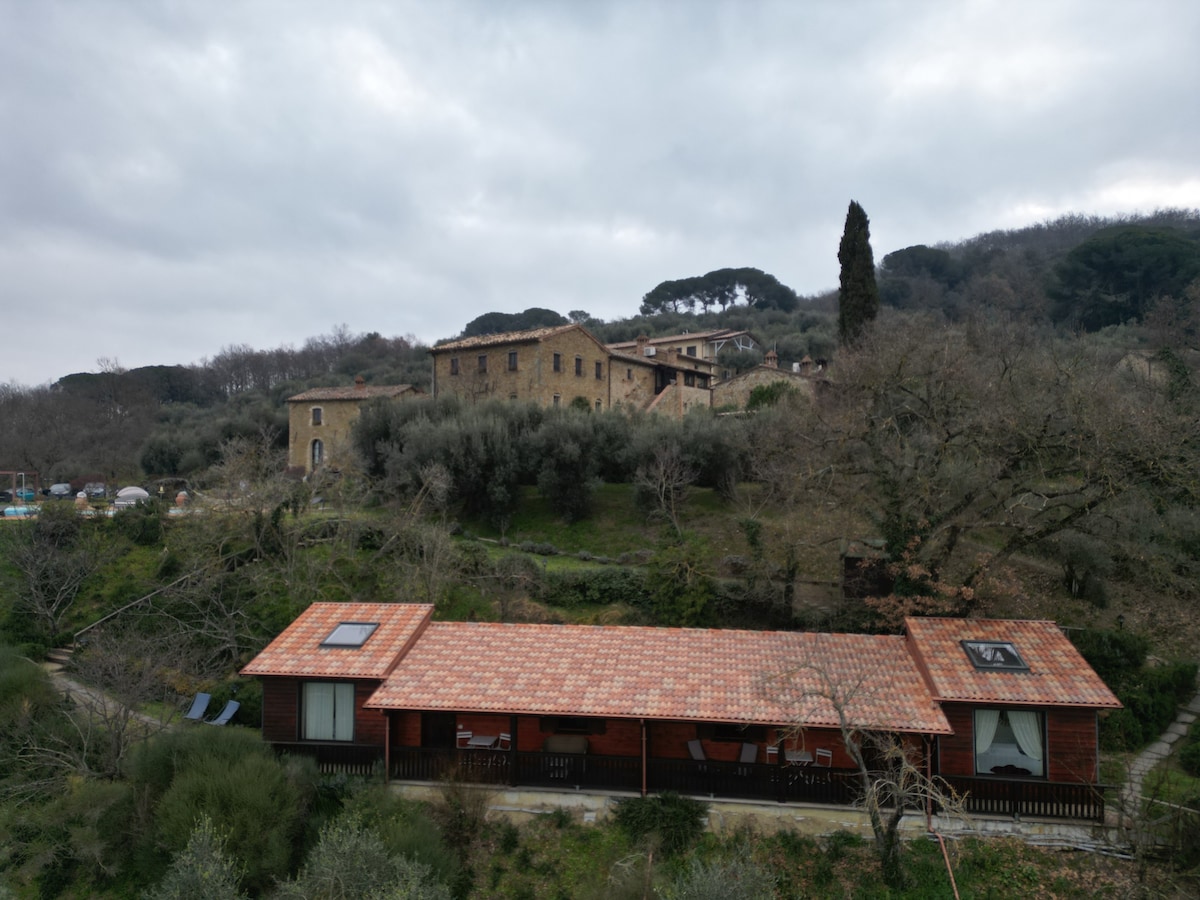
top-left (906, 618), bottom-right (1121, 708)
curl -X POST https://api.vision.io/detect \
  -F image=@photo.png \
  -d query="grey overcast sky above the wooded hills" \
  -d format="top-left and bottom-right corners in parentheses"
top-left (0, 0), bottom-right (1200, 385)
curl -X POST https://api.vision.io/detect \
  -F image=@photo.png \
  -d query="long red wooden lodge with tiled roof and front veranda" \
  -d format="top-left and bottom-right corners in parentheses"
top-left (242, 604), bottom-right (1120, 821)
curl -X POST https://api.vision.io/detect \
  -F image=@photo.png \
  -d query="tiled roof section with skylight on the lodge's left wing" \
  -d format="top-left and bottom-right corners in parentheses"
top-left (241, 604), bottom-right (433, 678)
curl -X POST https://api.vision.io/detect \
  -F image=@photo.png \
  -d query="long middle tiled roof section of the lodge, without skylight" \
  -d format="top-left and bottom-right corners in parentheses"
top-left (366, 623), bottom-right (950, 734)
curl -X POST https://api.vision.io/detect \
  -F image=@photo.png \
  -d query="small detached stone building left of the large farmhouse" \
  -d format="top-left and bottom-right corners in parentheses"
top-left (287, 376), bottom-right (422, 475)
